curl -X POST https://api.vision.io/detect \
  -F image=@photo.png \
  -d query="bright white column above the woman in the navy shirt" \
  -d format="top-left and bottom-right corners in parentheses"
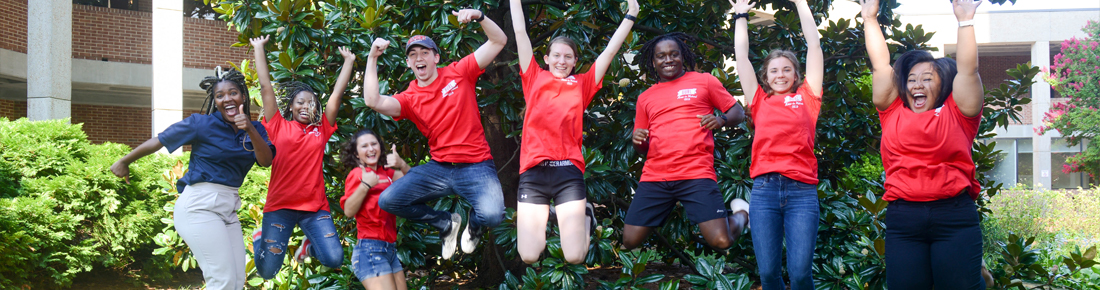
top-left (152, 0), bottom-right (184, 150)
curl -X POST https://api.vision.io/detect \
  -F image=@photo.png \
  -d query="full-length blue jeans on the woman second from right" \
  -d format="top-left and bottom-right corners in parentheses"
top-left (749, 174), bottom-right (821, 290)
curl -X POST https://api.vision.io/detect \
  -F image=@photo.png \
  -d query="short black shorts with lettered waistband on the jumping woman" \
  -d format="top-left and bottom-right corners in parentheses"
top-left (517, 160), bottom-right (585, 205)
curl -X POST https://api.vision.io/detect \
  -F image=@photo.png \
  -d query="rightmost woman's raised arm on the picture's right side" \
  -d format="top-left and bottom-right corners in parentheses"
top-left (941, 0), bottom-right (985, 116)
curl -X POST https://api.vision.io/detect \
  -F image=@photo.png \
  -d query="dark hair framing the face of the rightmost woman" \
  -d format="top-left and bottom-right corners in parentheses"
top-left (893, 51), bottom-right (958, 109)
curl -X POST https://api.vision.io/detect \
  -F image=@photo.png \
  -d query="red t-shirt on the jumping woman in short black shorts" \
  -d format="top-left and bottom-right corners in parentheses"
top-left (519, 56), bottom-right (603, 174)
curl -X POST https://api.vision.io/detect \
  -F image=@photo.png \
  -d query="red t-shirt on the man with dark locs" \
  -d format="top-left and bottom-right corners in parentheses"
top-left (634, 71), bottom-right (737, 181)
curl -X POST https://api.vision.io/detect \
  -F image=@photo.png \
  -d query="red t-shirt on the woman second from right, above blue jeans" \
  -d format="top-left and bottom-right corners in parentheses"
top-left (749, 81), bottom-right (822, 185)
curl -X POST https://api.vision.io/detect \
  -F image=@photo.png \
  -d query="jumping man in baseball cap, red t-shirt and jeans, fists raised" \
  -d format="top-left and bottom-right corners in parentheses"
top-left (363, 9), bottom-right (508, 259)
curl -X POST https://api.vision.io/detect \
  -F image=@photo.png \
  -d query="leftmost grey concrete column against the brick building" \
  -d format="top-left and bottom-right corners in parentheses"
top-left (26, 0), bottom-right (73, 121)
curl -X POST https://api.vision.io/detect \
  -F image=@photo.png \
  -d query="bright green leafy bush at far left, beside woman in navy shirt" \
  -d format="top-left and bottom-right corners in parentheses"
top-left (0, 119), bottom-right (187, 288)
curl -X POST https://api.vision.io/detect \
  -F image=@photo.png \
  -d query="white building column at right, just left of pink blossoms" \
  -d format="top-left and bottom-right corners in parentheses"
top-left (1031, 41), bottom-right (1060, 189)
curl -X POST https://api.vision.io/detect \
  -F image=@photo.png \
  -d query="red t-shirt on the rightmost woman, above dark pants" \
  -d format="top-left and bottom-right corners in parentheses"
top-left (879, 96), bottom-right (981, 202)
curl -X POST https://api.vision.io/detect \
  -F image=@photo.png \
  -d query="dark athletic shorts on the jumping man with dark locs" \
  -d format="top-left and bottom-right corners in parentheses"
top-left (624, 178), bottom-right (729, 227)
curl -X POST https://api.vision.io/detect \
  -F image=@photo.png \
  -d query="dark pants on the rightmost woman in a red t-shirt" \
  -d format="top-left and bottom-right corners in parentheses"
top-left (886, 192), bottom-right (986, 290)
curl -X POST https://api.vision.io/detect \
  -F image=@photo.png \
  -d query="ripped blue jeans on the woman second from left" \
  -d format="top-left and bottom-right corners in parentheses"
top-left (252, 210), bottom-right (343, 279)
